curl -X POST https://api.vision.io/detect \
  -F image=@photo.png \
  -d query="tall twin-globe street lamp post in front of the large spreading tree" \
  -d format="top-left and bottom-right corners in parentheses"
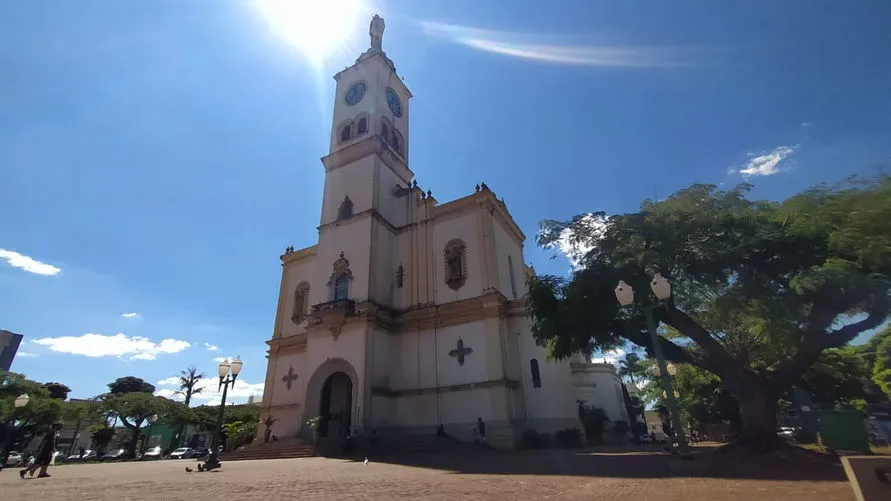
top-left (616, 273), bottom-right (693, 459)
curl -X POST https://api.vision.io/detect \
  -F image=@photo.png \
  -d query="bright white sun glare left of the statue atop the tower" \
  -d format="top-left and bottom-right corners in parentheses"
top-left (256, 0), bottom-right (362, 64)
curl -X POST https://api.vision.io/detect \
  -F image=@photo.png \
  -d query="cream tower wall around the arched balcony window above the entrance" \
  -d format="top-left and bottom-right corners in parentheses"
top-left (310, 217), bottom-right (372, 304)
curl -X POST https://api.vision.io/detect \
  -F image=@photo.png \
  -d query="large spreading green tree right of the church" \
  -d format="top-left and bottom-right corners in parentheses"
top-left (529, 177), bottom-right (891, 446)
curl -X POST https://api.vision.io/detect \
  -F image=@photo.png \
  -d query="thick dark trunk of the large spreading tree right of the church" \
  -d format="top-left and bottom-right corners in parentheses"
top-left (731, 381), bottom-right (781, 451)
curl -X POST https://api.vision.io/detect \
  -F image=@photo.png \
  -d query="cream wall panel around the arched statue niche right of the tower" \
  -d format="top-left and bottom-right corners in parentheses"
top-left (427, 211), bottom-right (484, 304)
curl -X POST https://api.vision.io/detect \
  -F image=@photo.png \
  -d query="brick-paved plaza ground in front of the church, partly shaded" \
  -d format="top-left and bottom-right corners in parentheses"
top-left (0, 451), bottom-right (854, 501)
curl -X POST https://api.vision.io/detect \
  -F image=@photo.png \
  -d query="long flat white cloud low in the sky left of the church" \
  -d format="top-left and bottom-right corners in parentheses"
top-left (33, 332), bottom-right (191, 360)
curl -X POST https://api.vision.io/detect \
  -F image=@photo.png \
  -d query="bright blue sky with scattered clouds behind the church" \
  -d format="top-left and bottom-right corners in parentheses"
top-left (0, 0), bottom-right (891, 399)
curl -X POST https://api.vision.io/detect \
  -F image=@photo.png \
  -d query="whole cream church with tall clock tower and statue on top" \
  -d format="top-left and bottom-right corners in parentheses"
top-left (258, 16), bottom-right (628, 448)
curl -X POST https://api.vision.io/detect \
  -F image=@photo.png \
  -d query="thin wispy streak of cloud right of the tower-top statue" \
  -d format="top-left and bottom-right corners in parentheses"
top-left (422, 21), bottom-right (690, 67)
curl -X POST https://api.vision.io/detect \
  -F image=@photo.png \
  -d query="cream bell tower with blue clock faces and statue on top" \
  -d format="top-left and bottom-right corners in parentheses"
top-left (313, 15), bottom-right (414, 303)
